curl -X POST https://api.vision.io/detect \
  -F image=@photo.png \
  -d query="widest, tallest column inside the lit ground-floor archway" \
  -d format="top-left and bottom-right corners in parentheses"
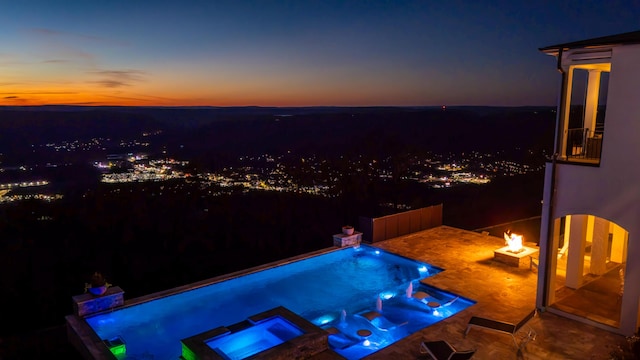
top-left (564, 215), bottom-right (587, 289)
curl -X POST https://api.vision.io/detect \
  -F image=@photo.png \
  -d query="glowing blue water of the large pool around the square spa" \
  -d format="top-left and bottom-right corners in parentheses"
top-left (86, 245), bottom-right (473, 359)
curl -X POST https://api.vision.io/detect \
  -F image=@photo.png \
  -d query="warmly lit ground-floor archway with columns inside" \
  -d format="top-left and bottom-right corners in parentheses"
top-left (548, 214), bottom-right (629, 327)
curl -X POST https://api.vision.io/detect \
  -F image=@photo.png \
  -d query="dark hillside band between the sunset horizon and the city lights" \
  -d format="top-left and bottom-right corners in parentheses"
top-left (0, 107), bottom-right (555, 156)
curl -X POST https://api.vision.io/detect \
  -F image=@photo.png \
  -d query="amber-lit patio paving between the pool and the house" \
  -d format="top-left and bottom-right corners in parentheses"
top-left (360, 226), bottom-right (624, 360)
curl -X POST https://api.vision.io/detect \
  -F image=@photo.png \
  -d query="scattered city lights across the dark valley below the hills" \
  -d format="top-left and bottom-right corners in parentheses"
top-left (0, 127), bottom-right (545, 205)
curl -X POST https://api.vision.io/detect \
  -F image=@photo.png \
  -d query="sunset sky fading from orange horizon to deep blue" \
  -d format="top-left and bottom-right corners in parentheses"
top-left (0, 0), bottom-right (640, 106)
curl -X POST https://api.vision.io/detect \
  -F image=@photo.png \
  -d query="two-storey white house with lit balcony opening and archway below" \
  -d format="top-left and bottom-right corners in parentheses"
top-left (536, 31), bottom-right (640, 335)
